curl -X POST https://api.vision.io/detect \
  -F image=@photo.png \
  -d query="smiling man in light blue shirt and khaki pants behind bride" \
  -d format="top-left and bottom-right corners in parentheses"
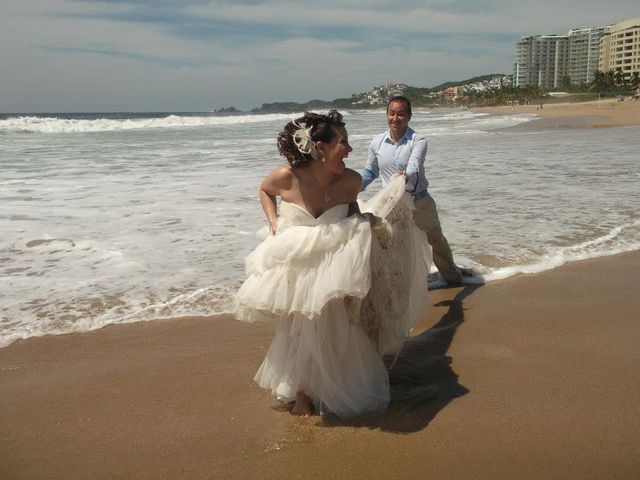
top-left (361, 96), bottom-right (465, 285)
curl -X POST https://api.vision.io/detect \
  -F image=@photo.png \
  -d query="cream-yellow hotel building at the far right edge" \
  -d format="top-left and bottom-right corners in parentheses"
top-left (598, 17), bottom-right (640, 80)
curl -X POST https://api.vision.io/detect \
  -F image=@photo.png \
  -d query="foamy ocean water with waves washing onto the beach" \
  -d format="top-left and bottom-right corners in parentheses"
top-left (0, 110), bottom-right (640, 346)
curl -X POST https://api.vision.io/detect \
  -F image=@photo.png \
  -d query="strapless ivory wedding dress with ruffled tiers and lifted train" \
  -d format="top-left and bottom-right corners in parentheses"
top-left (236, 177), bottom-right (430, 418)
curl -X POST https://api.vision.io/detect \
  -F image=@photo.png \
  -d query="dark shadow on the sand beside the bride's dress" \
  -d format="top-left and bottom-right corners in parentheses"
top-left (321, 285), bottom-right (480, 433)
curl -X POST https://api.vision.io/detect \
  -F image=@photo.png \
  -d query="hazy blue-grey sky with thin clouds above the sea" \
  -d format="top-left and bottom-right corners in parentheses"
top-left (0, 0), bottom-right (640, 113)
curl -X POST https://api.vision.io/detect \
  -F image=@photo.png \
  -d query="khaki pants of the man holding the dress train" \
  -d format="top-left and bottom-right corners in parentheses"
top-left (413, 195), bottom-right (462, 283)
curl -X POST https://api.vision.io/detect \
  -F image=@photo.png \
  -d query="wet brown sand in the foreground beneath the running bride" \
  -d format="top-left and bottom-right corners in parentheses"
top-left (0, 252), bottom-right (640, 480)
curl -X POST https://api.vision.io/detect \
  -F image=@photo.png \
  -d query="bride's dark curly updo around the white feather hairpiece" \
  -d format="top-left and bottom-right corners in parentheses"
top-left (278, 110), bottom-right (344, 168)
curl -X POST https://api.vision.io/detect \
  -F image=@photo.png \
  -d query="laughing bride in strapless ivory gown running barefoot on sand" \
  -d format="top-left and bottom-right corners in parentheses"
top-left (236, 110), bottom-right (429, 418)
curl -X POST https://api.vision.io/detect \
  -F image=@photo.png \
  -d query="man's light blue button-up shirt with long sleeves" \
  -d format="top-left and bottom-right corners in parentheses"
top-left (360, 127), bottom-right (429, 195)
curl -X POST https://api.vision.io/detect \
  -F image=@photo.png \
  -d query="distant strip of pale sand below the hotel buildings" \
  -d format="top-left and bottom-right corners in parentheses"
top-left (473, 99), bottom-right (640, 129)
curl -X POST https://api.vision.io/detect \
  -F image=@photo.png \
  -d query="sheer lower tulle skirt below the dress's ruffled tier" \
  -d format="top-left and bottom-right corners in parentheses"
top-left (254, 299), bottom-right (389, 418)
